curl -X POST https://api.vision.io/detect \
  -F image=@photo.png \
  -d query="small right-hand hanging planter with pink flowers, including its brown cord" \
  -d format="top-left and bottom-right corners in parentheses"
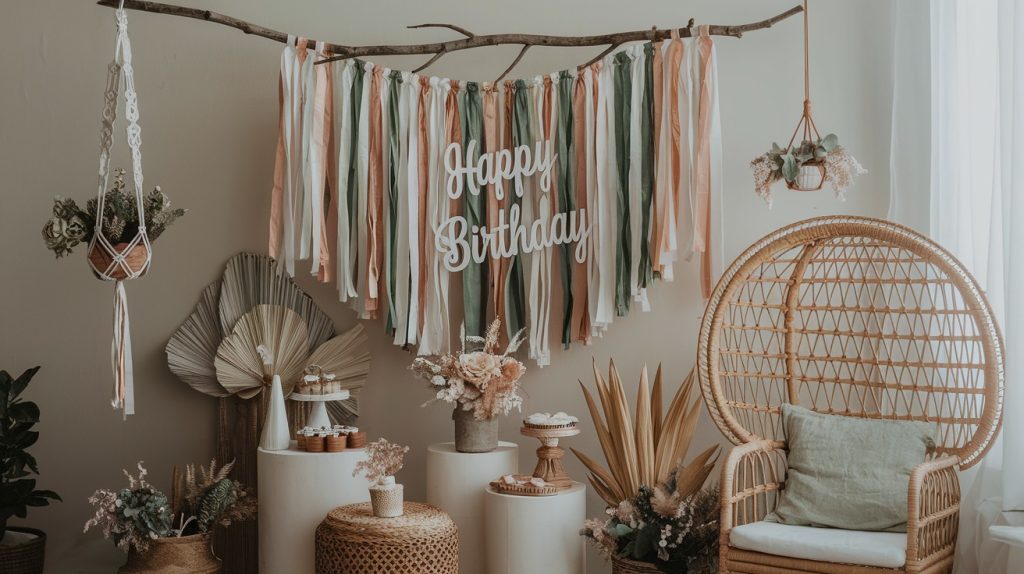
top-left (751, 0), bottom-right (867, 207)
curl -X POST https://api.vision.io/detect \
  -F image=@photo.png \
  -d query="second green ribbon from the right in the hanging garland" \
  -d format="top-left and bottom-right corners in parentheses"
top-left (612, 52), bottom-right (633, 317)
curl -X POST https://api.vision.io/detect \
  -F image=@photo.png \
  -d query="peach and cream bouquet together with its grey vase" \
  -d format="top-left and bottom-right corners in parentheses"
top-left (410, 319), bottom-right (526, 452)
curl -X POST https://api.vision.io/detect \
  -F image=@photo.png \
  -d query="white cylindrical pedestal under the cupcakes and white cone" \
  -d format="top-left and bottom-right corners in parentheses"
top-left (256, 441), bottom-right (370, 574)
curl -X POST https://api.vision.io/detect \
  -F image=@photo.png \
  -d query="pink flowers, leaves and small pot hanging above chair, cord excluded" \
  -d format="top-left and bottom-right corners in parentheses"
top-left (751, 134), bottom-right (867, 207)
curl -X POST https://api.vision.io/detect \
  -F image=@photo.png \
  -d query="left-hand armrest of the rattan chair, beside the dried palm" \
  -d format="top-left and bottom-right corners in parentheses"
top-left (719, 440), bottom-right (785, 532)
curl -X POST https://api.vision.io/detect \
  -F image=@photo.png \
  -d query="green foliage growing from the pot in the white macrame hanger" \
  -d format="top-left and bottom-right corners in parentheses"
top-left (43, 169), bottom-right (187, 258)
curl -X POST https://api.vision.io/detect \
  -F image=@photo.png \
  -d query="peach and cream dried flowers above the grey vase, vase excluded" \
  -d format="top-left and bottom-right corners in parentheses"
top-left (411, 319), bottom-right (526, 421)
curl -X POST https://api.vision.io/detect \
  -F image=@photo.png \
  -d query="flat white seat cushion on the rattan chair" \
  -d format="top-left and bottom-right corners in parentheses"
top-left (729, 522), bottom-right (906, 568)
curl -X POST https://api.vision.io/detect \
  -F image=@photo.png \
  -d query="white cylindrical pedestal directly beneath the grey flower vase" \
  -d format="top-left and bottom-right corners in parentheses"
top-left (427, 441), bottom-right (519, 574)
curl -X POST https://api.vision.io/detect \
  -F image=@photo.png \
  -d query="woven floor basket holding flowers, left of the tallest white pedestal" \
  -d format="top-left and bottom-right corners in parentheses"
top-left (118, 534), bottom-right (222, 574)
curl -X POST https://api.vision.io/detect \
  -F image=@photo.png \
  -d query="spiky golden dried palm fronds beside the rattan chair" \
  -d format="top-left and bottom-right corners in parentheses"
top-left (572, 361), bottom-right (719, 506)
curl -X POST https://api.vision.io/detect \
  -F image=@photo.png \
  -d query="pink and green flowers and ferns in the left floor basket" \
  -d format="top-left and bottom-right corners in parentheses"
top-left (84, 460), bottom-right (256, 562)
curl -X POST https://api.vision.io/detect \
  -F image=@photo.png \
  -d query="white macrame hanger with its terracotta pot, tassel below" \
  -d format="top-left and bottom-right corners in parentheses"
top-left (89, 0), bottom-right (153, 417)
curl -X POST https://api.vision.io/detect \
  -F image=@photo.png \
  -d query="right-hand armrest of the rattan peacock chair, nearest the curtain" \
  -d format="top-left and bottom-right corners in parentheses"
top-left (906, 456), bottom-right (961, 570)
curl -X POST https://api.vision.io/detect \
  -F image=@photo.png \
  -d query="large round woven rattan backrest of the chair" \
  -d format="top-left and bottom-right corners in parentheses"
top-left (697, 217), bottom-right (1004, 469)
